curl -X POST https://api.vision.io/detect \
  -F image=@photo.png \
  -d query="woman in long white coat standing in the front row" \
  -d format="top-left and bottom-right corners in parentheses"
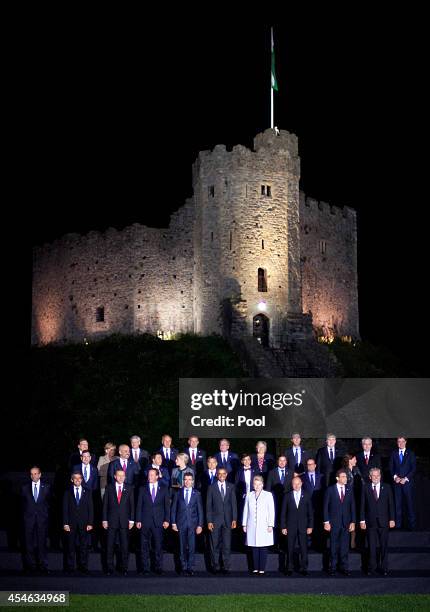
top-left (242, 476), bottom-right (275, 574)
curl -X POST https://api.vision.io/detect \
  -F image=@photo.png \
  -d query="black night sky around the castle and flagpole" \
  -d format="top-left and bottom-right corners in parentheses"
top-left (16, 9), bottom-right (427, 368)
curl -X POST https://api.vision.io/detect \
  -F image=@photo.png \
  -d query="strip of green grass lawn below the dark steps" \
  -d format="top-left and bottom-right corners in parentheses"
top-left (26, 594), bottom-right (430, 612)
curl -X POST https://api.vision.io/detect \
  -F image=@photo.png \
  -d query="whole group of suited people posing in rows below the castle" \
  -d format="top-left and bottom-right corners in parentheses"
top-left (21, 433), bottom-right (416, 576)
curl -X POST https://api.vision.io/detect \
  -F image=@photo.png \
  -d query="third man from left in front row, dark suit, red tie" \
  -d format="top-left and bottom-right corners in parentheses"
top-left (102, 469), bottom-right (134, 576)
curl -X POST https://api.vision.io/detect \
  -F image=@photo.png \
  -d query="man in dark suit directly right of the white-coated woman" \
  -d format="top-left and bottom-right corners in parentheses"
top-left (280, 476), bottom-right (314, 576)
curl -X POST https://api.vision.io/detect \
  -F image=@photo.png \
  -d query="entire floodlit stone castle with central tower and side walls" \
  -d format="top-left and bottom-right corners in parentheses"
top-left (32, 129), bottom-right (359, 347)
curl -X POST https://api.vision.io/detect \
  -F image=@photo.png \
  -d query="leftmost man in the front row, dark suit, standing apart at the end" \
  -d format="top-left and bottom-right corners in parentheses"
top-left (21, 465), bottom-right (51, 574)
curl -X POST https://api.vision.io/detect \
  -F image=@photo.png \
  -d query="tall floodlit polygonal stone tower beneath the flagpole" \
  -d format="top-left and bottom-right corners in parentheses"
top-left (193, 129), bottom-right (303, 346)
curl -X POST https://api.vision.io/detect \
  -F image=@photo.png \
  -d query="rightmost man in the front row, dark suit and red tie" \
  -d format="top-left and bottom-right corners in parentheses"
top-left (360, 468), bottom-right (395, 576)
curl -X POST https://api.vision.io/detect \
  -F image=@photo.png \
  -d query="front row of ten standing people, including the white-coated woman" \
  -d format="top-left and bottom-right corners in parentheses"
top-left (24, 467), bottom-right (395, 575)
